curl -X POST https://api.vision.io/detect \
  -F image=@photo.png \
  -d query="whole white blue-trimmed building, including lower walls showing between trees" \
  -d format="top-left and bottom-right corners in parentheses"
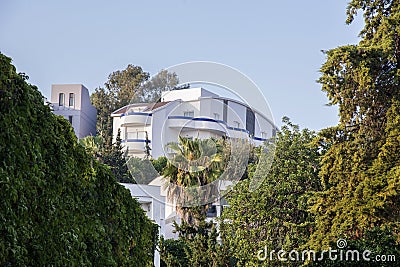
top-left (111, 88), bottom-right (277, 266)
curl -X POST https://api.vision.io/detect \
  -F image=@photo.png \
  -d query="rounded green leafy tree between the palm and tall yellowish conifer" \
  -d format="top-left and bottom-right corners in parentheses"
top-left (220, 118), bottom-right (320, 266)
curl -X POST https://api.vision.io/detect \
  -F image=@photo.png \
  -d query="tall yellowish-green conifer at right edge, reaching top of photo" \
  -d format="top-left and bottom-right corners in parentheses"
top-left (308, 0), bottom-right (400, 248)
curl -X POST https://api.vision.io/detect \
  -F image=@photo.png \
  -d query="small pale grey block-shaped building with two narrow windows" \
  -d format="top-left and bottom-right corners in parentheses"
top-left (50, 84), bottom-right (97, 138)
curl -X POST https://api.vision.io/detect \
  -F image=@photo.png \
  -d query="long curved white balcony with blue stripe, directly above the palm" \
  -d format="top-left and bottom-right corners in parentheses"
top-left (168, 116), bottom-right (227, 134)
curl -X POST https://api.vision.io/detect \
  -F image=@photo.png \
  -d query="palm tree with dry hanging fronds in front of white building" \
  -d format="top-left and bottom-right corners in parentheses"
top-left (163, 137), bottom-right (229, 225)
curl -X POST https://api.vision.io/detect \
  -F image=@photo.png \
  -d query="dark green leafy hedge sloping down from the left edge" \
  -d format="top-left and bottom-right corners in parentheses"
top-left (0, 54), bottom-right (157, 266)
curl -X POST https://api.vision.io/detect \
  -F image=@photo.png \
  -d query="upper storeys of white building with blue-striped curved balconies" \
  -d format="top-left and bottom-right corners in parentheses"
top-left (111, 88), bottom-right (277, 158)
